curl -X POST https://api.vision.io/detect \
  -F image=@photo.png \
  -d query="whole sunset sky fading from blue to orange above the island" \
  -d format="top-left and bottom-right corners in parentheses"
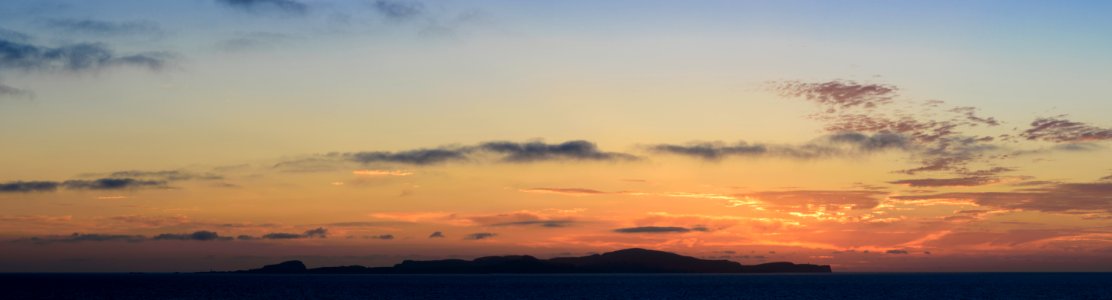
top-left (0, 0), bottom-right (1112, 272)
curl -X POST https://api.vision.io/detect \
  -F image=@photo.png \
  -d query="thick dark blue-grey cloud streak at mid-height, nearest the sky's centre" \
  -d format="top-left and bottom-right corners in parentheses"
top-left (479, 140), bottom-right (637, 162)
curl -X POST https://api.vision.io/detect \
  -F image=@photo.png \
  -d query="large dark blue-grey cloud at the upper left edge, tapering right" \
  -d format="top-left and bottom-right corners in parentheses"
top-left (0, 39), bottom-right (170, 71)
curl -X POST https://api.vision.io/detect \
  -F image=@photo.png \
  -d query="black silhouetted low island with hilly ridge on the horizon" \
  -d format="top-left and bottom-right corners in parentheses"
top-left (219, 248), bottom-right (831, 274)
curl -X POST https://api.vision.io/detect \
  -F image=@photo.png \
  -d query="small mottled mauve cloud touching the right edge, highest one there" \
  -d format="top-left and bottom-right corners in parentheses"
top-left (1020, 116), bottom-right (1112, 143)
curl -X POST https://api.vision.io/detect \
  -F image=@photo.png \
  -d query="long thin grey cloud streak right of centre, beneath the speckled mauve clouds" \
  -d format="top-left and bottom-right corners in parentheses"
top-left (648, 132), bottom-right (910, 161)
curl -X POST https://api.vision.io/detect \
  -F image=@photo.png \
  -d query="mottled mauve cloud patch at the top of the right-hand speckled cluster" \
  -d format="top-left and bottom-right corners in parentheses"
top-left (771, 80), bottom-right (898, 110)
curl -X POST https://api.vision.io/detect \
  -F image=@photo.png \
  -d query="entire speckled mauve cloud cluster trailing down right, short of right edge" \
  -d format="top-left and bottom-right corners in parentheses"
top-left (771, 80), bottom-right (1006, 174)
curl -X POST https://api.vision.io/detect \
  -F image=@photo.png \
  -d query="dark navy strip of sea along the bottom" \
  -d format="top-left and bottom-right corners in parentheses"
top-left (0, 273), bottom-right (1112, 299)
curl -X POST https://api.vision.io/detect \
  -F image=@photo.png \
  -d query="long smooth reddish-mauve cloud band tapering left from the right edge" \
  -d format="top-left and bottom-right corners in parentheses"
top-left (892, 182), bottom-right (1112, 212)
